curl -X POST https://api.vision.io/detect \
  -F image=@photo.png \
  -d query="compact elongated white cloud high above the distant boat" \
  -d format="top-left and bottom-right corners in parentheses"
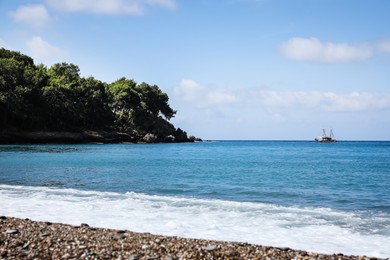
top-left (280, 38), bottom-right (373, 62)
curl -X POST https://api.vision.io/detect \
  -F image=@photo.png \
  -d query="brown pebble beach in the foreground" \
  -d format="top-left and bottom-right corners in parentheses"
top-left (0, 216), bottom-right (380, 260)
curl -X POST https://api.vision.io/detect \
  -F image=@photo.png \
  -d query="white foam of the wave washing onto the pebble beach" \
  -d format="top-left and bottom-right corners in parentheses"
top-left (0, 185), bottom-right (390, 257)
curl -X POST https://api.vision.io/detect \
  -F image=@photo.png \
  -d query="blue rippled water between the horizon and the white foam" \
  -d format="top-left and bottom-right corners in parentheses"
top-left (0, 141), bottom-right (390, 212)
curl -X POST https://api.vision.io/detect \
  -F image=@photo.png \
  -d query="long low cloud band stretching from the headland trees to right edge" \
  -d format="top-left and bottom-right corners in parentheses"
top-left (174, 79), bottom-right (390, 113)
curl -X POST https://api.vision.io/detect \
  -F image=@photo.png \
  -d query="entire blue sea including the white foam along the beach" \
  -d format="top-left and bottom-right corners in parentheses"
top-left (0, 141), bottom-right (390, 258)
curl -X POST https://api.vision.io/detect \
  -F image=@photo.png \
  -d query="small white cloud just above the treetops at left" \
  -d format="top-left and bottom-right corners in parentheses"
top-left (26, 36), bottom-right (65, 63)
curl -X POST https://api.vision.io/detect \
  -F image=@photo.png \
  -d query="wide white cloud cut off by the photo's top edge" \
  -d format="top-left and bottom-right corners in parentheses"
top-left (46, 0), bottom-right (176, 15)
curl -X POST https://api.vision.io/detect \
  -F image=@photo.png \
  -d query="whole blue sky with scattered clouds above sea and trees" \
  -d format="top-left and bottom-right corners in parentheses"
top-left (0, 0), bottom-right (390, 140)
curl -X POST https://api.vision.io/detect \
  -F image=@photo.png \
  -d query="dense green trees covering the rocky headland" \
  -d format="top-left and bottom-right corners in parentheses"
top-left (0, 48), bottom-right (195, 142)
